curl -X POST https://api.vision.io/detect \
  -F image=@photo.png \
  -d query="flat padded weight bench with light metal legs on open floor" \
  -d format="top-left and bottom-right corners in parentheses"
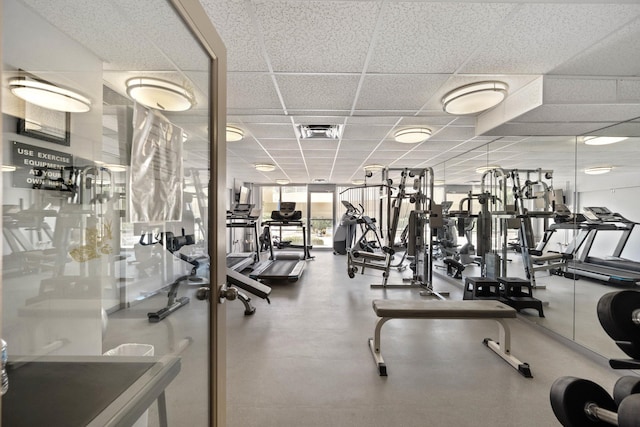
top-left (369, 299), bottom-right (532, 378)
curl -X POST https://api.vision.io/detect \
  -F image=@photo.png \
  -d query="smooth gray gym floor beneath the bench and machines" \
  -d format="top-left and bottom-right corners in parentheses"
top-left (105, 251), bottom-right (628, 427)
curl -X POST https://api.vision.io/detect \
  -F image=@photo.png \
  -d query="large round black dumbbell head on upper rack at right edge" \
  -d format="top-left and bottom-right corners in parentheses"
top-left (597, 290), bottom-right (640, 359)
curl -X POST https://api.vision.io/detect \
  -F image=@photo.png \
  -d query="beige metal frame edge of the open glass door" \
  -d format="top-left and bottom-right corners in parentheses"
top-left (169, 0), bottom-right (227, 427)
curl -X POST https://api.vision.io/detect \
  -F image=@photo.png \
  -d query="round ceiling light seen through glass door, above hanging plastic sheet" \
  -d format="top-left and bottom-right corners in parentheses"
top-left (125, 77), bottom-right (196, 111)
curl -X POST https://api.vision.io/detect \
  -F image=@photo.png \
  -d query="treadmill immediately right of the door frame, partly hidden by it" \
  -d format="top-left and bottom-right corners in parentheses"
top-left (226, 203), bottom-right (260, 271)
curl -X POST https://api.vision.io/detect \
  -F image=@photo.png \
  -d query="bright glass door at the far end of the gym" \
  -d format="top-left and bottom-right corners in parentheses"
top-left (307, 188), bottom-right (335, 249)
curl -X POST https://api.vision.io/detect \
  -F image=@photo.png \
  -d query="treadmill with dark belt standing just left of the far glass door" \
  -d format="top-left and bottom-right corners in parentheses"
top-left (249, 202), bottom-right (312, 282)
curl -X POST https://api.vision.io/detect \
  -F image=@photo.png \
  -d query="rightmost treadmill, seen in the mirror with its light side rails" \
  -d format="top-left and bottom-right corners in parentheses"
top-left (565, 207), bottom-right (640, 285)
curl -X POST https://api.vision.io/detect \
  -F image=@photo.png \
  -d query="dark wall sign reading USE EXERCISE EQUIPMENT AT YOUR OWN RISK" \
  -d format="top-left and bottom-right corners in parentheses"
top-left (11, 141), bottom-right (73, 190)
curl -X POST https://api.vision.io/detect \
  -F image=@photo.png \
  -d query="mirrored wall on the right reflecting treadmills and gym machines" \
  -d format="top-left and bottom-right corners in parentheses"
top-left (434, 120), bottom-right (640, 358)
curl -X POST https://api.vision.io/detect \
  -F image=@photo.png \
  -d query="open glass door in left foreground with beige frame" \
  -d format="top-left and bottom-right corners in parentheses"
top-left (0, 0), bottom-right (226, 426)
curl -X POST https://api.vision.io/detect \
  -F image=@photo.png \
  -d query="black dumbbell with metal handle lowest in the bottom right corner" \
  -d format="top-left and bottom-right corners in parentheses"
top-left (550, 377), bottom-right (640, 427)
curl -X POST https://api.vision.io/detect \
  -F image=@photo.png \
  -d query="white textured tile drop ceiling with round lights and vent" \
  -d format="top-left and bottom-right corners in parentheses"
top-left (16, 0), bottom-right (640, 186)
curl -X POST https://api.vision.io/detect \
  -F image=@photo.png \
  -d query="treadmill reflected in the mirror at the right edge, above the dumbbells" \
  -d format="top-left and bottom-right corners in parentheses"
top-left (566, 207), bottom-right (640, 285)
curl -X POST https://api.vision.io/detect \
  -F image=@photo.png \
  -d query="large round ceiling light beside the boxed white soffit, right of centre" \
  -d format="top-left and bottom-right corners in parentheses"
top-left (442, 81), bottom-right (509, 115)
